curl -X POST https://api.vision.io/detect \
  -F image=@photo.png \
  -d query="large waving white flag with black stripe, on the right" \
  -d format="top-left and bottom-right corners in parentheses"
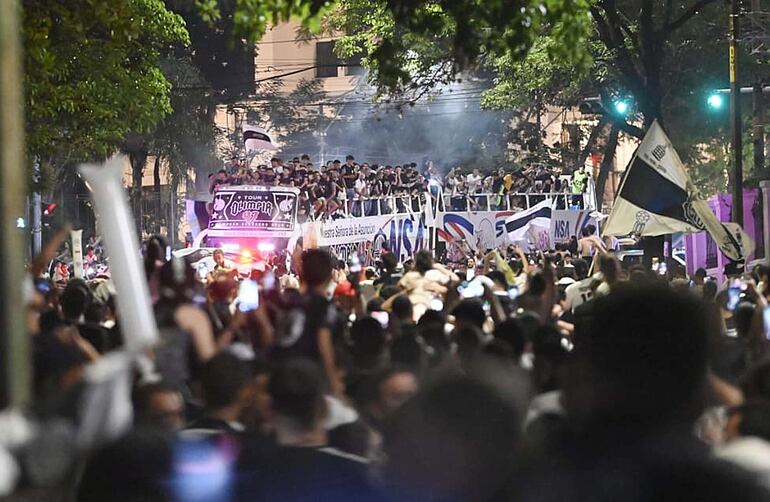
top-left (603, 121), bottom-right (753, 261)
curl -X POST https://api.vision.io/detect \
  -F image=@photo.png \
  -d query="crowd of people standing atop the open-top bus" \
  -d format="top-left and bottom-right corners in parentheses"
top-left (209, 155), bottom-right (589, 221)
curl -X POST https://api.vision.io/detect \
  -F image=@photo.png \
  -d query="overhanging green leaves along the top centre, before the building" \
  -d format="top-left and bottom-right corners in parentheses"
top-left (197, 0), bottom-right (591, 98)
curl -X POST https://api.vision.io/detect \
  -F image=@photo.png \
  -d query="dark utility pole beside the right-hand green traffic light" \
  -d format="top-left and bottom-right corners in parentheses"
top-left (729, 0), bottom-right (743, 226)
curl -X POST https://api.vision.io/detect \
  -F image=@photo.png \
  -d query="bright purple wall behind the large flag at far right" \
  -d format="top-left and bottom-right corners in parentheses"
top-left (685, 183), bottom-right (770, 283)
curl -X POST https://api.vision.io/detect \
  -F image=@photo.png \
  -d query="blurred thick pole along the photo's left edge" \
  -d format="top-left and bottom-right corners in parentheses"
top-left (0, 0), bottom-right (30, 409)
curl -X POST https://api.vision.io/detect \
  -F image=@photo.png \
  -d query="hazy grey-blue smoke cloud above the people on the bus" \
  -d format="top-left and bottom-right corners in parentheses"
top-left (282, 78), bottom-right (511, 172)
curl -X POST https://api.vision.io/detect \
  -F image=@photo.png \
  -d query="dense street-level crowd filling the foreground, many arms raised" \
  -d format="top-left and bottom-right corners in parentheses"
top-left (7, 226), bottom-right (770, 502)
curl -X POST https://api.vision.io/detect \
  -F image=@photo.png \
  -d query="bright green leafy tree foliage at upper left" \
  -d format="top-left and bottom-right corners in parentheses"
top-left (22, 0), bottom-right (189, 166)
